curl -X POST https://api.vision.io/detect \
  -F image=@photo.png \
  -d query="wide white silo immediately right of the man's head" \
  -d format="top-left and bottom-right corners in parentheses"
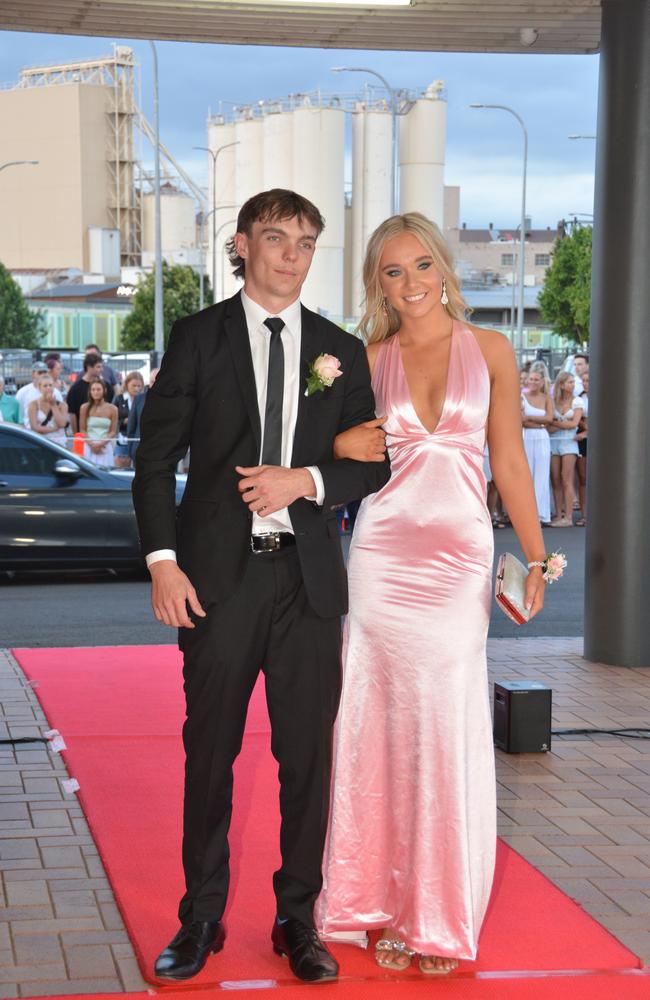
top-left (292, 98), bottom-right (345, 319)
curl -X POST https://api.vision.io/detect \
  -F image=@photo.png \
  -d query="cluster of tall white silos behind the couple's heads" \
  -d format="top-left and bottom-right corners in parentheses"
top-left (208, 82), bottom-right (447, 319)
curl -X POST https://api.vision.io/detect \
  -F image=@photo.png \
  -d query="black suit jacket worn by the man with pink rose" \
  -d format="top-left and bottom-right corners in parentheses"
top-left (133, 294), bottom-right (390, 617)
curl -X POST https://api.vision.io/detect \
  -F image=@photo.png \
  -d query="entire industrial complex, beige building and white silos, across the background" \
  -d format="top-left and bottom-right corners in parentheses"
top-left (0, 45), bottom-right (557, 350)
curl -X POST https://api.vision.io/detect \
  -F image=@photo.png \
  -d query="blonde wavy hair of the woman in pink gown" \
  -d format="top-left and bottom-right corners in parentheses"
top-left (357, 212), bottom-right (471, 344)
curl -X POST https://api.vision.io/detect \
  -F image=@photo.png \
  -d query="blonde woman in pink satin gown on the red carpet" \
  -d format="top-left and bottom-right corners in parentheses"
top-left (317, 213), bottom-right (544, 974)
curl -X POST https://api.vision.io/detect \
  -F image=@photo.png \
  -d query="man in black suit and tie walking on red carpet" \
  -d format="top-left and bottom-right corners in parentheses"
top-left (133, 189), bottom-right (389, 982)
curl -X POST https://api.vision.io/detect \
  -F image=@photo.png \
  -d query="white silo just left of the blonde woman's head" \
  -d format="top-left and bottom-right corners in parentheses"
top-left (350, 102), bottom-right (393, 317)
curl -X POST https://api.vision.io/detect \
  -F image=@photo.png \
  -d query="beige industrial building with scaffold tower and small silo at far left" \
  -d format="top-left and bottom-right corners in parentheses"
top-left (0, 45), bottom-right (206, 282)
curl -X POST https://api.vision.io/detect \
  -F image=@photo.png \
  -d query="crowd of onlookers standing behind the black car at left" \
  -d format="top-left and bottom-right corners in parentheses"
top-left (0, 344), bottom-right (157, 469)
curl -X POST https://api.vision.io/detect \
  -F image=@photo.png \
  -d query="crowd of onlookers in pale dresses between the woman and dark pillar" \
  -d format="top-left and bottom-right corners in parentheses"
top-left (485, 353), bottom-right (589, 528)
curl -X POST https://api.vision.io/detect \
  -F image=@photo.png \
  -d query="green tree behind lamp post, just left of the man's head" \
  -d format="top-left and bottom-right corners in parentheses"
top-left (122, 261), bottom-right (212, 351)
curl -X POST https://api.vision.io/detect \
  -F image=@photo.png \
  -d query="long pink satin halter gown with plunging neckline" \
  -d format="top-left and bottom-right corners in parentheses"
top-left (316, 322), bottom-right (496, 959)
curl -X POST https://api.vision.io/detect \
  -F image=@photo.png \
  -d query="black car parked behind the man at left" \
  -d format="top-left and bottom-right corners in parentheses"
top-left (0, 423), bottom-right (184, 570)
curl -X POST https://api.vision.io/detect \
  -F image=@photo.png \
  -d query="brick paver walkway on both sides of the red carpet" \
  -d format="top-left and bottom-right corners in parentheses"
top-left (0, 638), bottom-right (650, 997)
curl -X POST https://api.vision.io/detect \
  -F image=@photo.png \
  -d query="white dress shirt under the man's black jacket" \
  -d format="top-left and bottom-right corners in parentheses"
top-left (146, 291), bottom-right (325, 566)
